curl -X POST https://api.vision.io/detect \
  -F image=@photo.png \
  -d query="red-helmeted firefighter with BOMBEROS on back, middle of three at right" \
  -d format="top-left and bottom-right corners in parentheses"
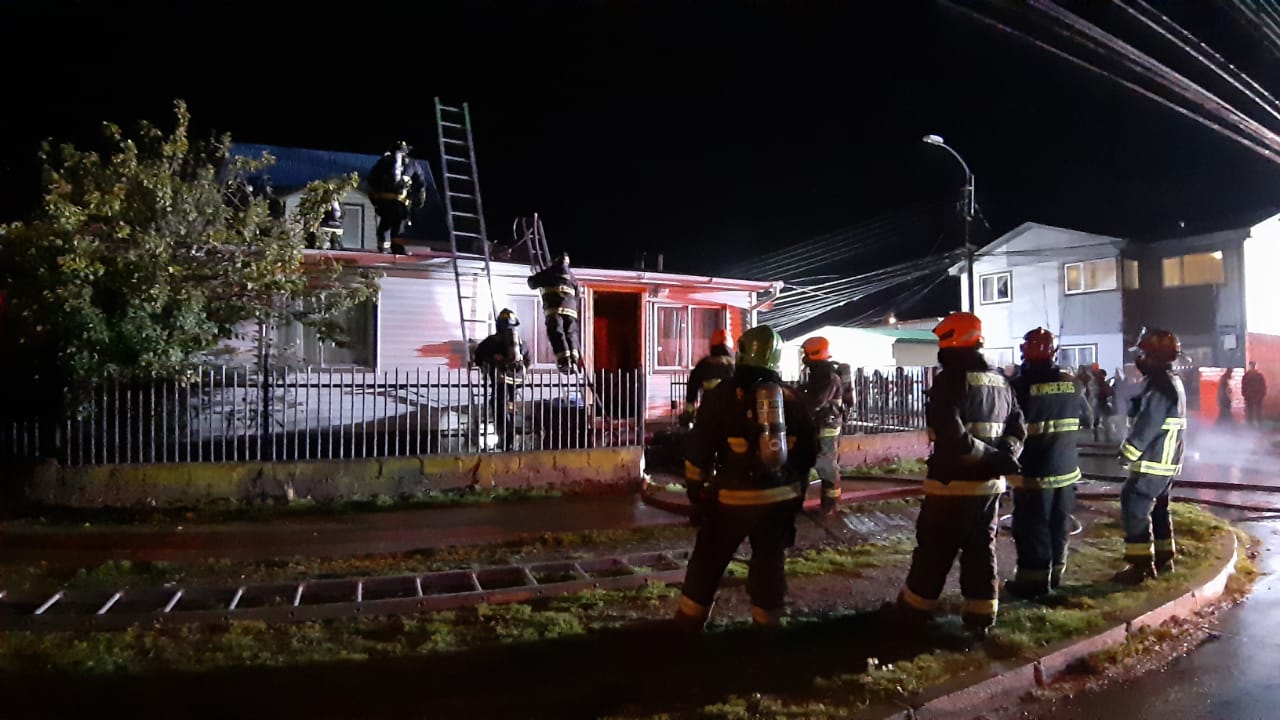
top-left (1005, 328), bottom-right (1093, 597)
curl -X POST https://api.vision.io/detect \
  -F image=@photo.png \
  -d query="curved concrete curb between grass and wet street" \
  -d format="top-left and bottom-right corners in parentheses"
top-left (884, 527), bottom-right (1239, 720)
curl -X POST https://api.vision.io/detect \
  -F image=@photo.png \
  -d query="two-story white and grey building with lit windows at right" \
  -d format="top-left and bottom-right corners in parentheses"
top-left (951, 214), bottom-right (1280, 413)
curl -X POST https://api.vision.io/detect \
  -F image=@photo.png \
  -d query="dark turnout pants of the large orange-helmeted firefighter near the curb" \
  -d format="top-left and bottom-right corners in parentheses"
top-left (899, 495), bottom-right (1000, 626)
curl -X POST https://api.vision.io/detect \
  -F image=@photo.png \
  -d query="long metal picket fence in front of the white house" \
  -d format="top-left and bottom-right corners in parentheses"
top-left (0, 368), bottom-right (644, 465)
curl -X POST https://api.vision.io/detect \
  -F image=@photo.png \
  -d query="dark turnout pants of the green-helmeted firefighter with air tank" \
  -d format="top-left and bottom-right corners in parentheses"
top-left (680, 500), bottom-right (797, 624)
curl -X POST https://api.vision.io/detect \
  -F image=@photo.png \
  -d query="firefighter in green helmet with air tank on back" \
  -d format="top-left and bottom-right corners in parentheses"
top-left (676, 325), bottom-right (818, 632)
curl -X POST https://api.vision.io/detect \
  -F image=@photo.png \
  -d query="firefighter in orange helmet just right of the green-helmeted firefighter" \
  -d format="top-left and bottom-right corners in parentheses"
top-left (800, 337), bottom-right (847, 514)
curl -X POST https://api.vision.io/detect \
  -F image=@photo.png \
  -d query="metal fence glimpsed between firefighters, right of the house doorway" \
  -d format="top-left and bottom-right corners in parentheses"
top-left (671, 368), bottom-right (936, 434)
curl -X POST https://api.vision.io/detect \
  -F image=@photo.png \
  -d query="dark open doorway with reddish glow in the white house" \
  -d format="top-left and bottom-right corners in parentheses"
top-left (591, 291), bottom-right (645, 418)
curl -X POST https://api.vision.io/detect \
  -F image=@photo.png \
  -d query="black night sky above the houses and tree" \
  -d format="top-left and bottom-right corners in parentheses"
top-left (0, 0), bottom-right (1280, 319)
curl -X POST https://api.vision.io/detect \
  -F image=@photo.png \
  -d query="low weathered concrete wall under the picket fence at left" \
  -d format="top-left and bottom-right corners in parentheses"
top-left (26, 447), bottom-right (644, 507)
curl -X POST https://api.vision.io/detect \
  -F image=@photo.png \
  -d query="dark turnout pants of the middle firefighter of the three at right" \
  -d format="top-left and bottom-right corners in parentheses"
top-left (1014, 484), bottom-right (1075, 591)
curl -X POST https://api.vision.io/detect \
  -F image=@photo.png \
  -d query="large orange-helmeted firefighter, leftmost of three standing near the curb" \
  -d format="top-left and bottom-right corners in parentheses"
top-left (895, 313), bottom-right (1027, 638)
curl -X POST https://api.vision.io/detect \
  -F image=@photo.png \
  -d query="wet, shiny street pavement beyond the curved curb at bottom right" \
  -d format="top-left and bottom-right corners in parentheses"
top-left (989, 520), bottom-right (1280, 720)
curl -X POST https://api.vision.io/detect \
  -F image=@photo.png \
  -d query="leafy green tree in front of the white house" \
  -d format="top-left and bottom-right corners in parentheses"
top-left (0, 100), bottom-right (376, 413)
